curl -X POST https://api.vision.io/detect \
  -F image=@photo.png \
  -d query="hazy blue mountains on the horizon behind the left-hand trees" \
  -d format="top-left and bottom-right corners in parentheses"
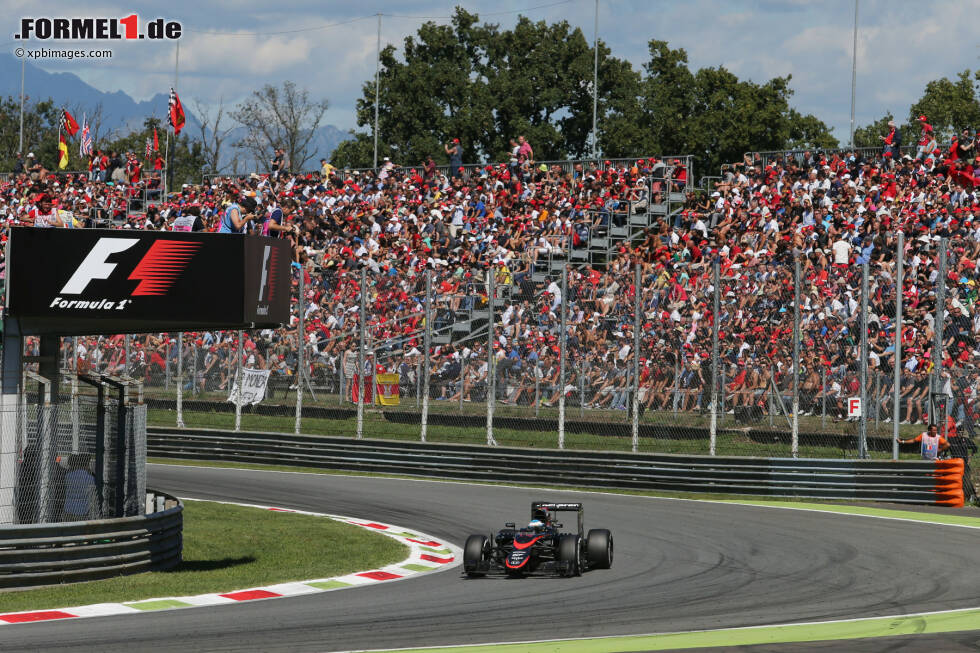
top-left (0, 54), bottom-right (350, 171)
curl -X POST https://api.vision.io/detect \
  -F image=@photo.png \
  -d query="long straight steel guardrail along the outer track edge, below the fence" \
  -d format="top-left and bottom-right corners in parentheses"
top-left (147, 427), bottom-right (960, 504)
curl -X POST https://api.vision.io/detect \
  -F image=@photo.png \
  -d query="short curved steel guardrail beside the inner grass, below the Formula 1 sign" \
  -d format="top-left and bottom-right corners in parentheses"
top-left (0, 492), bottom-right (184, 589)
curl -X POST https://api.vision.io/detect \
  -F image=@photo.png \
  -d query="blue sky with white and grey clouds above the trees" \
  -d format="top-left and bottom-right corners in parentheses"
top-left (0, 0), bottom-right (980, 141)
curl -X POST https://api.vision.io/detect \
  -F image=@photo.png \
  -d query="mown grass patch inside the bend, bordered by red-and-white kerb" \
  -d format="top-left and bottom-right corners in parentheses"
top-left (0, 501), bottom-right (408, 612)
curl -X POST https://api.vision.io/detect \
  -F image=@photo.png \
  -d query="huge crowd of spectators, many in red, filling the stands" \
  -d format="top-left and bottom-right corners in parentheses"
top-left (0, 116), bottom-right (980, 433)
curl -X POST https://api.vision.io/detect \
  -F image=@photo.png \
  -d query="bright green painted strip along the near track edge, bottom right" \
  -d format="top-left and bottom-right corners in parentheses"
top-left (378, 609), bottom-right (980, 653)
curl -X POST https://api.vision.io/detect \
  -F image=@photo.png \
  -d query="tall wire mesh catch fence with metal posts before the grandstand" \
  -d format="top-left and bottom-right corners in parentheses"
top-left (53, 236), bottom-right (980, 468)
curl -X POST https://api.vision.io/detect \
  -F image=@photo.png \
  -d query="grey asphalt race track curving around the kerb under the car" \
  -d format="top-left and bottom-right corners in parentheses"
top-left (0, 465), bottom-right (980, 653)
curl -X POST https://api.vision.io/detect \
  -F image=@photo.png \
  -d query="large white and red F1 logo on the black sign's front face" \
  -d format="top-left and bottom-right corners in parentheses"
top-left (61, 238), bottom-right (201, 297)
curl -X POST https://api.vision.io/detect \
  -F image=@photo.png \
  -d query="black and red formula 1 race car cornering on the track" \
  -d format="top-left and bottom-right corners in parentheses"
top-left (463, 501), bottom-right (613, 578)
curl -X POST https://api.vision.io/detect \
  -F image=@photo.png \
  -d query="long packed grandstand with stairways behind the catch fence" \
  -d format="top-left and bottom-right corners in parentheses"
top-left (0, 125), bottom-right (980, 464)
